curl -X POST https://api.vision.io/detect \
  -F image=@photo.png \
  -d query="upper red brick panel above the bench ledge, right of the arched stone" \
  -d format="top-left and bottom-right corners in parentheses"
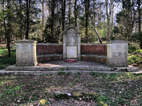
top-left (81, 44), bottom-right (107, 55)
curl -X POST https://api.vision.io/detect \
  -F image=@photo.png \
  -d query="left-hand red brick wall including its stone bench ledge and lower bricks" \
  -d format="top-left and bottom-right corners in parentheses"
top-left (37, 43), bottom-right (63, 63)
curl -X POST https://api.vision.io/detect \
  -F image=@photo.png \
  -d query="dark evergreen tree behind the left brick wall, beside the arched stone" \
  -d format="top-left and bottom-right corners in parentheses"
top-left (44, 0), bottom-right (61, 43)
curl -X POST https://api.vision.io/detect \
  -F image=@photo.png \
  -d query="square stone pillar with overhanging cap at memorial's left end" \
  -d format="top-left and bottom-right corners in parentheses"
top-left (15, 40), bottom-right (37, 66)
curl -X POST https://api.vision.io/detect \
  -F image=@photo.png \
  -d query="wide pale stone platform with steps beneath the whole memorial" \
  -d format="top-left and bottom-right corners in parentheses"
top-left (6, 61), bottom-right (139, 72)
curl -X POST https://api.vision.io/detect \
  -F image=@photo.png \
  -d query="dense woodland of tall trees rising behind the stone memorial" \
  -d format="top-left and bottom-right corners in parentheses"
top-left (0, 0), bottom-right (142, 57)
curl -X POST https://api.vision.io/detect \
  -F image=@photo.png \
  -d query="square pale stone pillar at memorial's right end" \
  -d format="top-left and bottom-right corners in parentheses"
top-left (107, 40), bottom-right (128, 67)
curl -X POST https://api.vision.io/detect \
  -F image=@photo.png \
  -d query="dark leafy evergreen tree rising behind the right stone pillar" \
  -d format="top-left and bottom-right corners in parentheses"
top-left (116, 0), bottom-right (136, 40)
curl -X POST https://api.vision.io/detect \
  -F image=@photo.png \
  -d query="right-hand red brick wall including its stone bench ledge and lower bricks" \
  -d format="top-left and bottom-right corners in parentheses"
top-left (81, 44), bottom-right (107, 64)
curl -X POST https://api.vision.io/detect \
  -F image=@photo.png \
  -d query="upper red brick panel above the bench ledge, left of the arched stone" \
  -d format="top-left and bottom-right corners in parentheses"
top-left (37, 43), bottom-right (63, 55)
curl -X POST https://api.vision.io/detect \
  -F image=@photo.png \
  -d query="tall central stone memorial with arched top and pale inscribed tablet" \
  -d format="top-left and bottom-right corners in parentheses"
top-left (63, 27), bottom-right (81, 60)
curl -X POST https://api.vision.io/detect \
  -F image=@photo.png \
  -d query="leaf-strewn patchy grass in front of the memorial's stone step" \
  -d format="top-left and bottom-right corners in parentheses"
top-left (0, 73), bottom-right (142, 106)
